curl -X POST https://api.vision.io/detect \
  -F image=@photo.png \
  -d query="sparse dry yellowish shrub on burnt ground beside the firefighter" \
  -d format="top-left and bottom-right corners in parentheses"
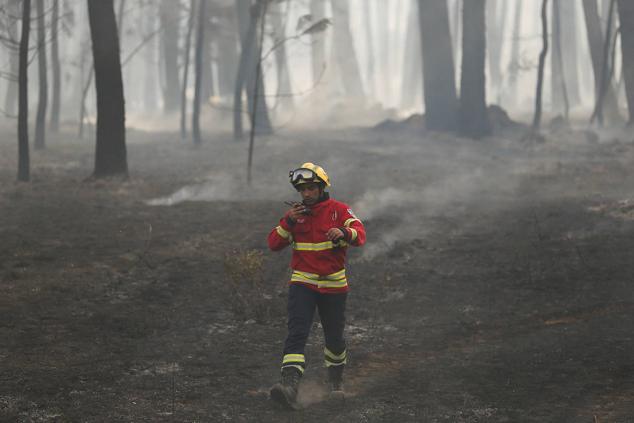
top-left (224, 250), bottom-right (272, 322)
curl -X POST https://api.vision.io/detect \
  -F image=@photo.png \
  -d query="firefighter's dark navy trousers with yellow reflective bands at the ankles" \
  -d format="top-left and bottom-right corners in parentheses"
top-left (282, 283), bottom-right (348, 373)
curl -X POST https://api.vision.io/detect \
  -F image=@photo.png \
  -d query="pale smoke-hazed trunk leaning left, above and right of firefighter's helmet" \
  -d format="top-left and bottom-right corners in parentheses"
top-left (332, 0), bottom-right (364, 100)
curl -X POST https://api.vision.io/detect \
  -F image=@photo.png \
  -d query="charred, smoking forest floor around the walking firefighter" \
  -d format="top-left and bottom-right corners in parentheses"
top-left (0, 120), bottom-right (634, 423)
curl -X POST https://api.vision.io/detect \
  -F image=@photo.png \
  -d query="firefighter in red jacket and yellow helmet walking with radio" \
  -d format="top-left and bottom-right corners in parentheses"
top-left (268, 163), bottom-right (365, 409)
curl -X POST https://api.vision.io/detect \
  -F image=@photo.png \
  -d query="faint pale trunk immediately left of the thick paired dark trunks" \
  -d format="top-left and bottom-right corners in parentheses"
top-left (401, 0), bottom-right (423, 108)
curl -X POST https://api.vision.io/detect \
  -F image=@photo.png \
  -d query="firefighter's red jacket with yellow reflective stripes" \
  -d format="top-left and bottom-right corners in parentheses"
top-left (268, 197), bottom-right (365, 294)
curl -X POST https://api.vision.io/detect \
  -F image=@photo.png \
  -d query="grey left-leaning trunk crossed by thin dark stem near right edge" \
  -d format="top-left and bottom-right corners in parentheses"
top-left (583, 0), bottom-right (621, 122)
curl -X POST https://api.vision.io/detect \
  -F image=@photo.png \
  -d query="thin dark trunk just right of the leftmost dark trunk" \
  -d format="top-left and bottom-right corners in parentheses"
top-left (34, 0), bottom-right (48, 150)
